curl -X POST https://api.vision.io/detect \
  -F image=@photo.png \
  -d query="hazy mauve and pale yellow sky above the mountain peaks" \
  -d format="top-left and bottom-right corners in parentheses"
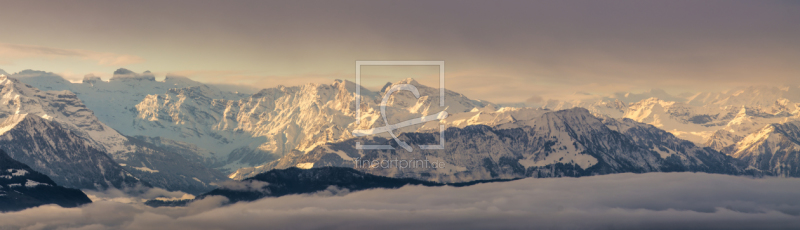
top-left (0, 0), bottom-right (800, 103)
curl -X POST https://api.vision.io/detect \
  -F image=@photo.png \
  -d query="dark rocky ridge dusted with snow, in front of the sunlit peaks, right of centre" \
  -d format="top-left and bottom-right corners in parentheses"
top-left (233, 109), bottom-right (747, 182)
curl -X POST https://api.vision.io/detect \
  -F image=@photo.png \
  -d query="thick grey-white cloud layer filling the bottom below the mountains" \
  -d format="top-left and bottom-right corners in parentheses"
top-left (0, 173), bottom-right (800, 229)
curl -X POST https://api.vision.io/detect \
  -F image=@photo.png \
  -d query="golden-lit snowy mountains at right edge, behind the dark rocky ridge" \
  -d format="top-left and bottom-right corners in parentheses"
top-left (545, 86), bottom-right (800, 176)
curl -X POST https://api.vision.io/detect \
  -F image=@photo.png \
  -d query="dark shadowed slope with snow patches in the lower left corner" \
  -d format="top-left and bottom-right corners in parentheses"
top-left (0, 150), bottom-right (92, 212)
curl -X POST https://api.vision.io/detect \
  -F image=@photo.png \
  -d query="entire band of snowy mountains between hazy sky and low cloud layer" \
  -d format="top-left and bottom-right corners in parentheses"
top-left (0, 69), bottom-right (800, 199)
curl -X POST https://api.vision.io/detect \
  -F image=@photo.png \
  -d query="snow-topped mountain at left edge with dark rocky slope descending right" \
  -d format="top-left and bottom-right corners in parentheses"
top-left (0, 72), bottom-right (226, 193)
